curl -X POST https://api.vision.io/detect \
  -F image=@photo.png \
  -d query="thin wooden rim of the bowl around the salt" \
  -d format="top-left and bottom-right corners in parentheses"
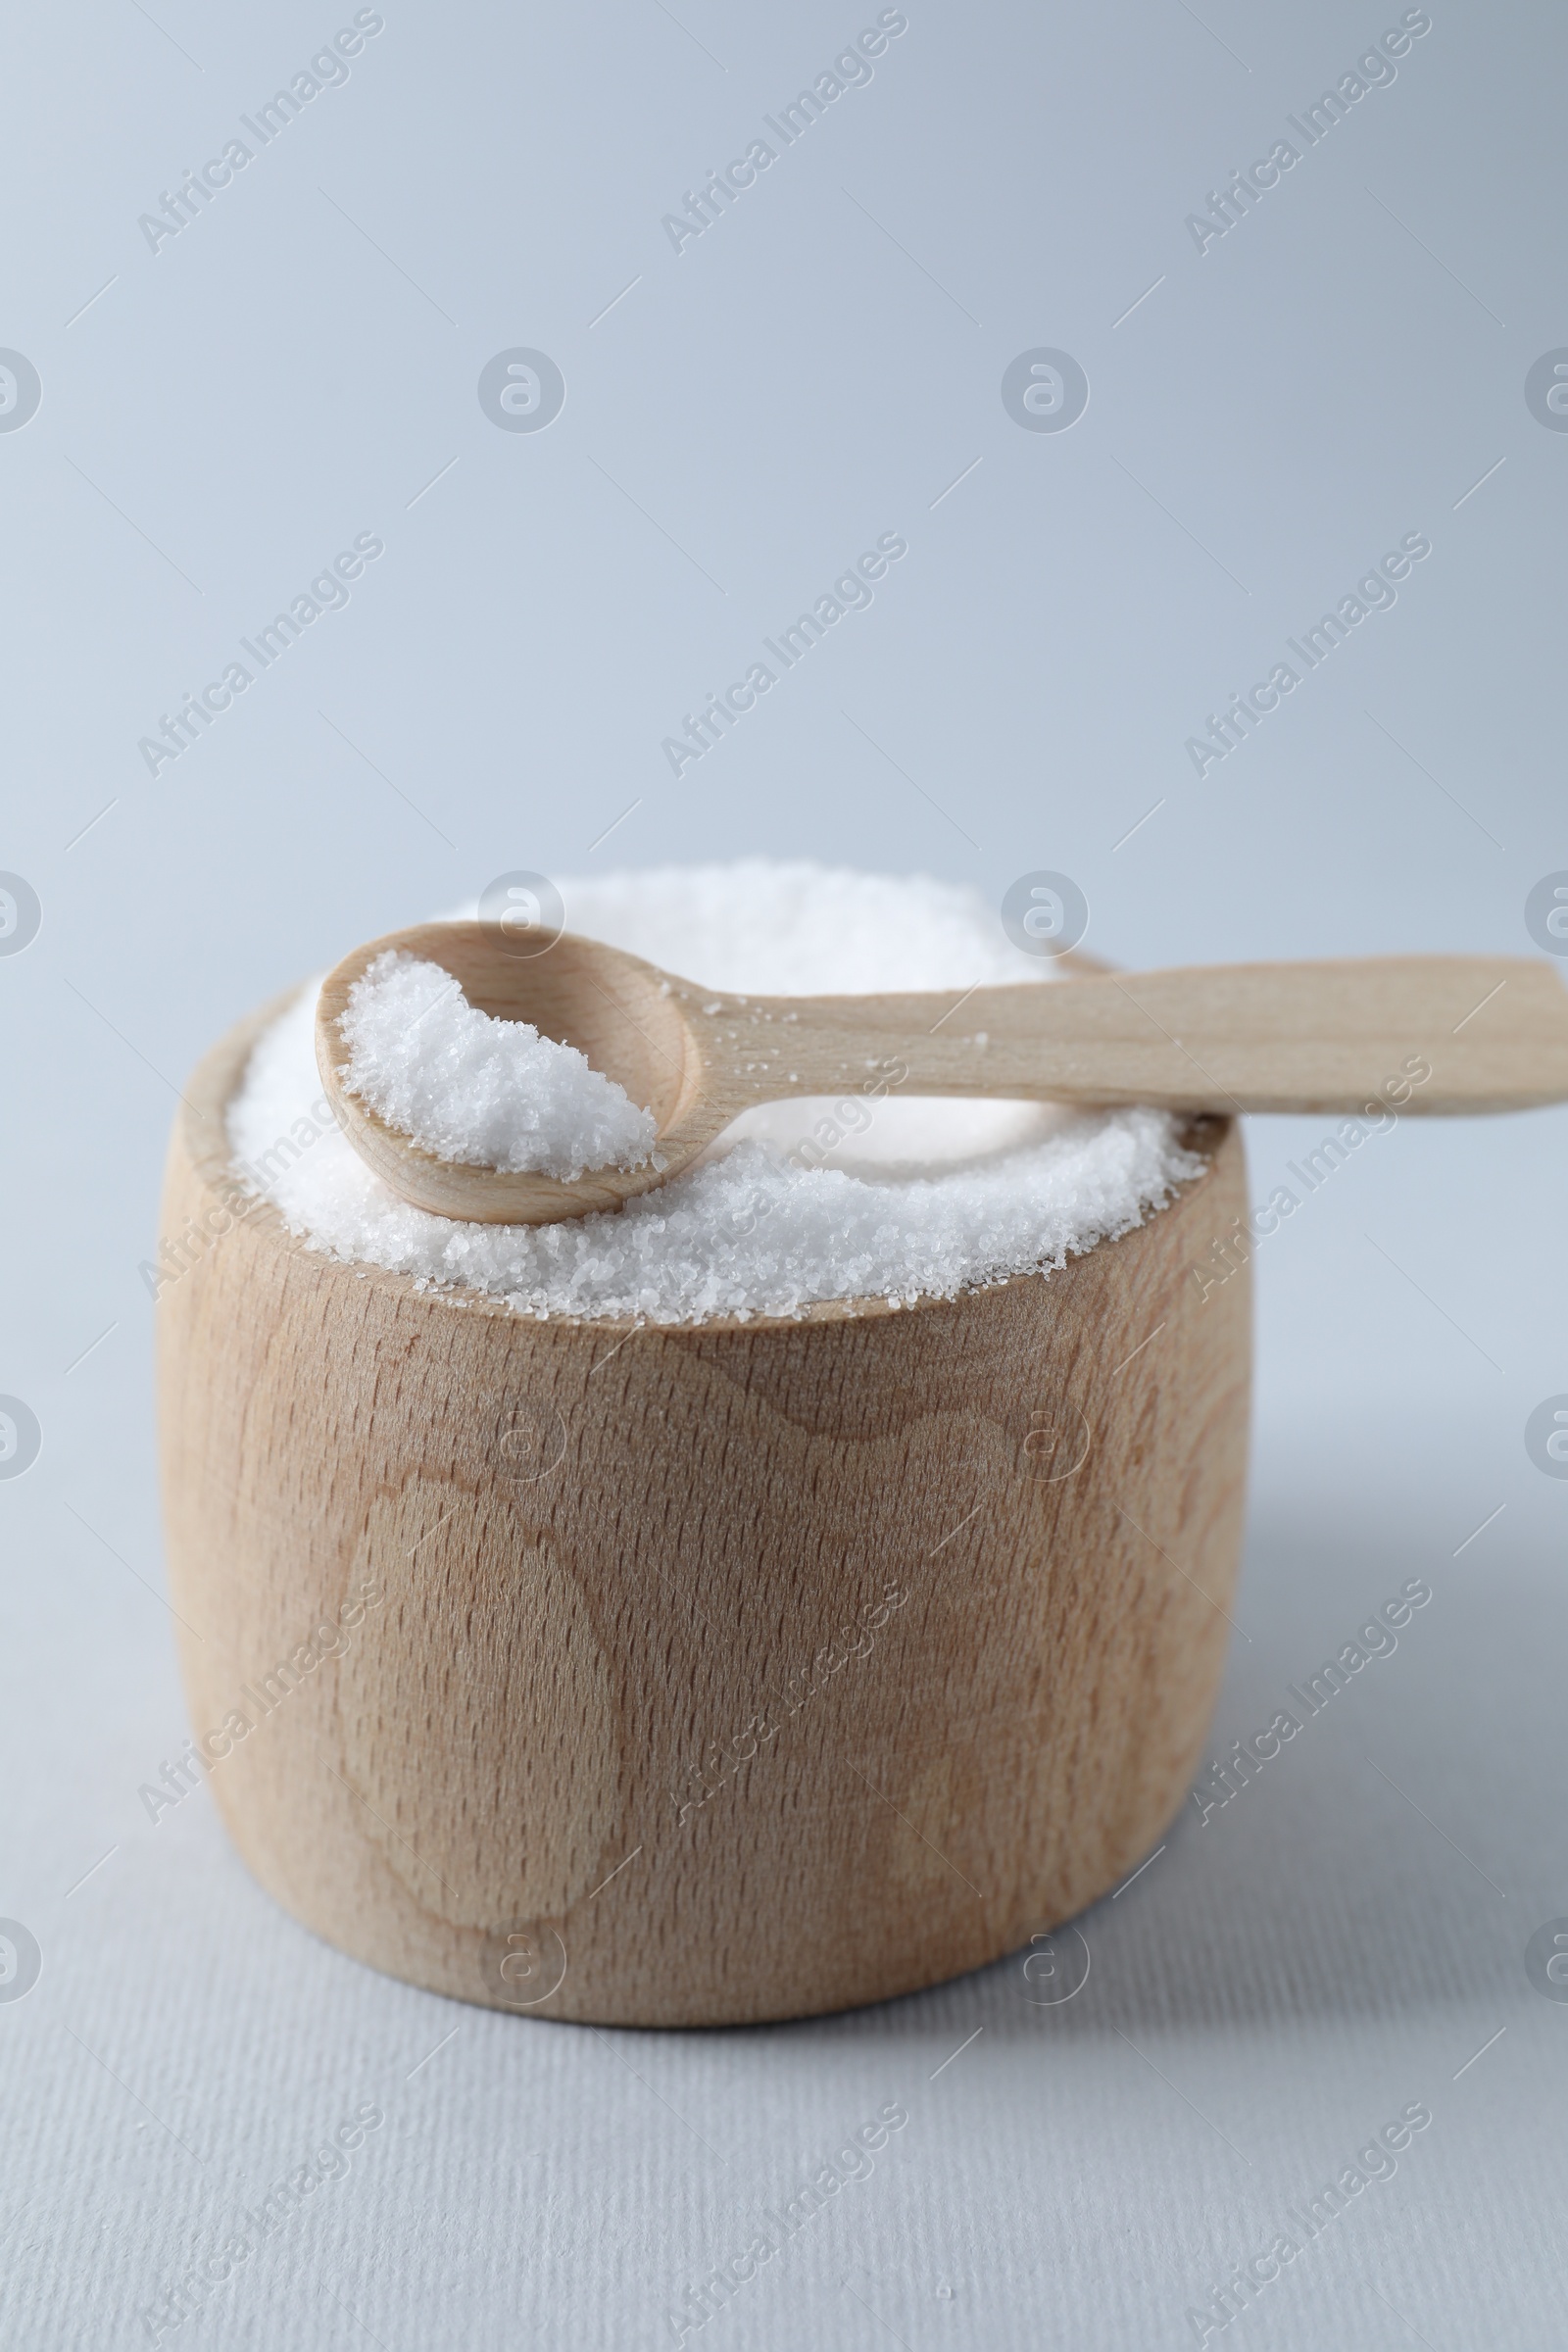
top-left (176, 951), bottom-right (1234, 1341)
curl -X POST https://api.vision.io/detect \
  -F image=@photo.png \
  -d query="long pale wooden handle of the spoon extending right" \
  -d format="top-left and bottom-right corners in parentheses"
top-left (714, 955), bottom-right (1568, 1115)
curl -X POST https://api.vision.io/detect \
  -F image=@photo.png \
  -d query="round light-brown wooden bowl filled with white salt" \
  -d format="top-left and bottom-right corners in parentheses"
top-left (158, 983), bottom-right (1250, 2025)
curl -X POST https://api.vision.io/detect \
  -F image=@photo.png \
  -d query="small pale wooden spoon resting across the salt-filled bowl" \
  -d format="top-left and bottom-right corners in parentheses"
top-left (315, 922), bottom-right (1568, 1225)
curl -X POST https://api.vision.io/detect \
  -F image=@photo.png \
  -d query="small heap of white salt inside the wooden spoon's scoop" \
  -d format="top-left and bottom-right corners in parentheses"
top-left (338, 948), bottom-right (656, 1181)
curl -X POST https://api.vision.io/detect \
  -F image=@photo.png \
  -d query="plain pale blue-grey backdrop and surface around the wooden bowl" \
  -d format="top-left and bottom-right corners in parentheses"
top-left (0, 0), bottom-right (1568, 2352)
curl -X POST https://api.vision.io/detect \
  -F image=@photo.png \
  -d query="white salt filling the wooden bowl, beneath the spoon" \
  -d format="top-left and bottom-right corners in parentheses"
top-left (230, 858), bottom-right (1203, 1322)
